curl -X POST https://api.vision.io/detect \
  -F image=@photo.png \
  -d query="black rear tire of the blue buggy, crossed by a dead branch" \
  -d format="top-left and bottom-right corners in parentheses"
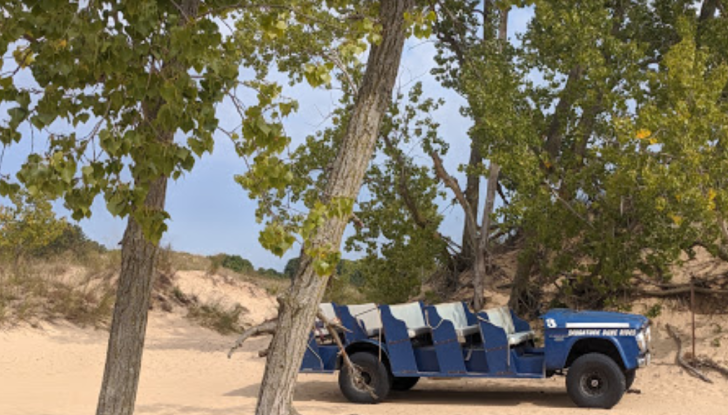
top-left (339, 352), bottom-right (391, 404)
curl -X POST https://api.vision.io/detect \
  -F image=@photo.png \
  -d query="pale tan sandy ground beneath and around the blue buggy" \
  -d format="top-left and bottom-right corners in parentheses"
top-left (0, 312), bottom-right (728, 415)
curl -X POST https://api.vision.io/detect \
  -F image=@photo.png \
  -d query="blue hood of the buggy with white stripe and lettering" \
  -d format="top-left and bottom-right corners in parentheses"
top-left (541, 309), bottom-right (649, 329)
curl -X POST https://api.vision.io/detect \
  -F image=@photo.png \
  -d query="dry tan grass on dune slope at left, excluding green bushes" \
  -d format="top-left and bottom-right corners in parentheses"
top-left (0, 246), bottom-right (290, 334)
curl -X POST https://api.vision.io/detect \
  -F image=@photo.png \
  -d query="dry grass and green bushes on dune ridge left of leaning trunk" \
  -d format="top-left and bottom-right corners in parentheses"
top-left (0, 195), bottom-right (286, 334)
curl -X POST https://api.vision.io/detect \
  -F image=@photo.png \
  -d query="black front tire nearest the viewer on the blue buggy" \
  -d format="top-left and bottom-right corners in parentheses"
top-left (566, 353), bottom-right (627, 409)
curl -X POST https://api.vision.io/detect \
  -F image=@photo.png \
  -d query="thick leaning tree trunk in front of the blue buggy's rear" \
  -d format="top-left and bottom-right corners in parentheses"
top-left (256, 0), bottom-right (414, 415)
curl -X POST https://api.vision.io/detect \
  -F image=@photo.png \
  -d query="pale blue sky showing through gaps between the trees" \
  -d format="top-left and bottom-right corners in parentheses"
top-left (0, 9), bottom-right (533, 271)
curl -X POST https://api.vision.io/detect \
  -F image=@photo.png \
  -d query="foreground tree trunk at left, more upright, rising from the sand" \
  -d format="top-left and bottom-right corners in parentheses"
top-left (96, 176), bottom-right (171, 415)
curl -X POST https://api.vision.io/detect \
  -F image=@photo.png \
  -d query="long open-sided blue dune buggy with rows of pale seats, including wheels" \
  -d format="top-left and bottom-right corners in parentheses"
top-left (301, 302), bottom-right (650, 408)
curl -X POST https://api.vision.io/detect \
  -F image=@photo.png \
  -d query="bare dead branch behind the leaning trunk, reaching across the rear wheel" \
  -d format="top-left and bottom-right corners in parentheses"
top-left (228, 311), bottom-right (377, 399)
